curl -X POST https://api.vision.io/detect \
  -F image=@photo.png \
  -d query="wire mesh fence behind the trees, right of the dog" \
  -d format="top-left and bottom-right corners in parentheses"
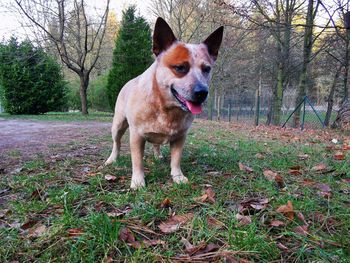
top-left (197, 91), bottom-right (338, 129)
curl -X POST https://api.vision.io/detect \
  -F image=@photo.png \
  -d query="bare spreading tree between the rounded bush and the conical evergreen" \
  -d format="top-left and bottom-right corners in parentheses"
top-left (15, 0), bottom-right (110, 114)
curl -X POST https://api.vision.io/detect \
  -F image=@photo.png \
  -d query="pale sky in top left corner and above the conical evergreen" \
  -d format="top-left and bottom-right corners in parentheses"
top-left (0, 0), bottom-right (152, 41)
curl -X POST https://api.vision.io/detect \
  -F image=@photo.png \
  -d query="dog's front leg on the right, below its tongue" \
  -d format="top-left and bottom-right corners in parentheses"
top-left (170, 136), bottom-right (188, 184)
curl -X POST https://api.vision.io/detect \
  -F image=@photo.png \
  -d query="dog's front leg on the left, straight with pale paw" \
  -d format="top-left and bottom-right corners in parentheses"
top-left (130, 129), bottom-right (145, 189)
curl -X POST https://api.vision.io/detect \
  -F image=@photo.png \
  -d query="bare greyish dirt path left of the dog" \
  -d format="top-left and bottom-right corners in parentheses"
top-left (0, 118), bottom-right (111, 174)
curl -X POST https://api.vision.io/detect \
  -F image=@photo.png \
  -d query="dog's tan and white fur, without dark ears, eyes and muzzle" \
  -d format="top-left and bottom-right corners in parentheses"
top-left (105, 20), bottom-right (223, 189)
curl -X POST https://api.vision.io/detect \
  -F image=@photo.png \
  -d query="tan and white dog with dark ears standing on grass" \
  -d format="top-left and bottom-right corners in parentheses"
top-left (105, 17), bottom-right (224, 189)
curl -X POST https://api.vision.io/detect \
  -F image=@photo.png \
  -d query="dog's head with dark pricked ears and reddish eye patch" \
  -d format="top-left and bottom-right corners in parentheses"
top-left (153, 17), bottom-right (224, 114)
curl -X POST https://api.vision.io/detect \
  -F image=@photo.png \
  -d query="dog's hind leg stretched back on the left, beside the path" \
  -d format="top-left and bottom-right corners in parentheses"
top-left (105, 115), bottom-right (129, 165)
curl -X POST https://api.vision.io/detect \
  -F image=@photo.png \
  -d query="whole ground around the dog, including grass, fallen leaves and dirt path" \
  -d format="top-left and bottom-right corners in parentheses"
top-left (0, 114), bottom-right (350, 262)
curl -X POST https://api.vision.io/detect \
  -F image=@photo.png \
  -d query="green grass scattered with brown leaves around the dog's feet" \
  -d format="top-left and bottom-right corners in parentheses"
top-left (0, 114), bottom-right (350, 262)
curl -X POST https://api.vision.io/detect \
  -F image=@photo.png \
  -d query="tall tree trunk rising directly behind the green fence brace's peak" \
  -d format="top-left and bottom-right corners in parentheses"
top-left (293, 0), bottom-right (317, 127)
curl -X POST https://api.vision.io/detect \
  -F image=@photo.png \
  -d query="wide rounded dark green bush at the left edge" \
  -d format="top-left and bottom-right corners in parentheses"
top-left (0, 38), bottom-right (67, 114)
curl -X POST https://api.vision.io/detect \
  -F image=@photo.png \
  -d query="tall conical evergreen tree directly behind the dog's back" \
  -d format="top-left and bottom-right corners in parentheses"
top-left (107, 6), bottom-right (153, 110)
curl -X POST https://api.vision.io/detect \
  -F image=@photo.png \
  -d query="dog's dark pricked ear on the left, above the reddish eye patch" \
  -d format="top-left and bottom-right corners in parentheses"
top-left (153, 17), bottom-right (176, 56)
